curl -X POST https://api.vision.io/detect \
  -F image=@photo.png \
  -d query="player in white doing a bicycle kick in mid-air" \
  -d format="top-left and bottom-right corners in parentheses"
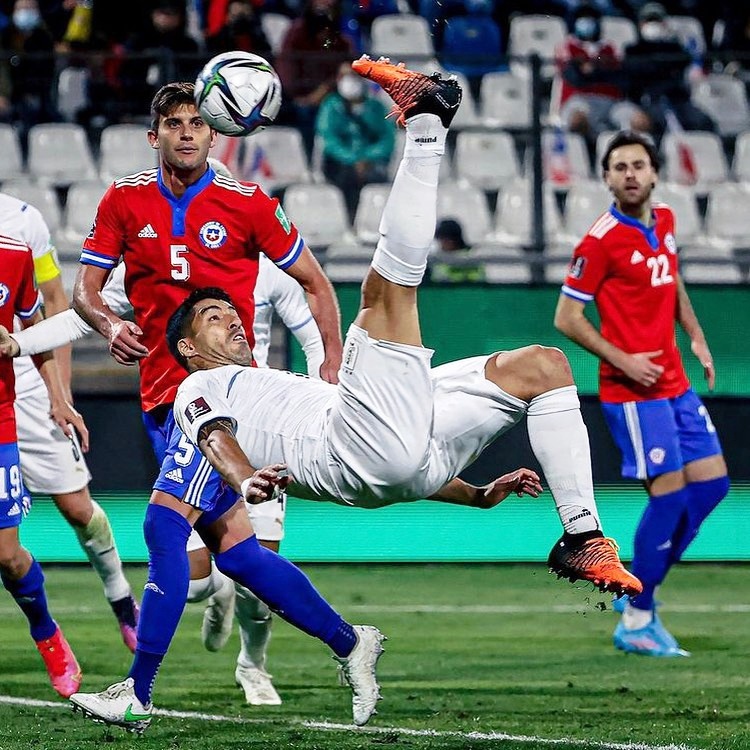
top-left (167, 56), bottom-right (641, 604)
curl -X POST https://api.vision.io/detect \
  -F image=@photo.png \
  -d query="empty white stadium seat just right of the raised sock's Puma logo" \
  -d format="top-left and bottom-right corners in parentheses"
top-left (453, 131), bottom-right (521, 190)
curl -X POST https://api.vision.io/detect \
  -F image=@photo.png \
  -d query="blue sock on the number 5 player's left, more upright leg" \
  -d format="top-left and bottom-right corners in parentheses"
top-left (128, 504), bottom-right (191, 705)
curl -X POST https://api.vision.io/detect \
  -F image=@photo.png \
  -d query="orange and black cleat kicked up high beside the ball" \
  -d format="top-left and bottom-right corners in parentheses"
top-left (352, 55), bottom-right (462, 128)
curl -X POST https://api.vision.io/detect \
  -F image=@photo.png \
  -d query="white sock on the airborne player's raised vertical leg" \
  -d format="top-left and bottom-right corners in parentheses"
top-left (372, 114), bottom-right (448, 286)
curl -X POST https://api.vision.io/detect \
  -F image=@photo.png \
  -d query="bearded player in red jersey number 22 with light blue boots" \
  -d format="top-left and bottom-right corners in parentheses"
top-left (555, 131), bottom-right (729, 656)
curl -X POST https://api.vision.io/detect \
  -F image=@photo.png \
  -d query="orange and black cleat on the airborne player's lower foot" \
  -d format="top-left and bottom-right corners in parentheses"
top-left (547, 534), bottom-right (643, 596)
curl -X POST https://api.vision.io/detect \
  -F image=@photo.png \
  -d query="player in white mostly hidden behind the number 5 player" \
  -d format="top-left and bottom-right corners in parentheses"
top-left (0, 241), bottom-right (324, 705)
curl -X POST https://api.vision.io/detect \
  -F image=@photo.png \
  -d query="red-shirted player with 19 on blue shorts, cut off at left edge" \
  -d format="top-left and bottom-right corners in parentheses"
top-left (0, 236), bottom-right (88, 698)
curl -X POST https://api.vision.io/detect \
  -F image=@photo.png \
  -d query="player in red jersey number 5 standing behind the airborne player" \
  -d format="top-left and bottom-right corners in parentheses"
top-left (73, 83), bottom-right (382, 730)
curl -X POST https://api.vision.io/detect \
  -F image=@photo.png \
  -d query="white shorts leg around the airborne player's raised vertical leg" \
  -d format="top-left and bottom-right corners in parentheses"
top-left (328, 326), bottom-right (433, 484)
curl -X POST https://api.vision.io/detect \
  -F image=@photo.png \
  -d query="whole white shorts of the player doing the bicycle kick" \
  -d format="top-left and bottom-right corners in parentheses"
top-left (328, 326), bottom-right (528, 508)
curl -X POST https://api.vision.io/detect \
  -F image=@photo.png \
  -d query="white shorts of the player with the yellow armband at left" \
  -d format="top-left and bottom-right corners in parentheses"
top-left (15, 388), bottom-right (91, 495)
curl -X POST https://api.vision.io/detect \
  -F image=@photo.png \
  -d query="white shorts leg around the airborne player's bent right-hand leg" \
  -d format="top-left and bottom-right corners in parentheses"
top-left (429, 355), bottom-right (527, 484)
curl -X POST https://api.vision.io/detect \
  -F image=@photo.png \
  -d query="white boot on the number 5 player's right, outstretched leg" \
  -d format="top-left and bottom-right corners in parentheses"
top-left (333, 625), bottom-right (386, 727)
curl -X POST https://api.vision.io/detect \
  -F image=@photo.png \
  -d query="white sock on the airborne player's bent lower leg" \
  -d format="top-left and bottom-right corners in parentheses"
top-left (526, 385), bottom-right (601, 534)
